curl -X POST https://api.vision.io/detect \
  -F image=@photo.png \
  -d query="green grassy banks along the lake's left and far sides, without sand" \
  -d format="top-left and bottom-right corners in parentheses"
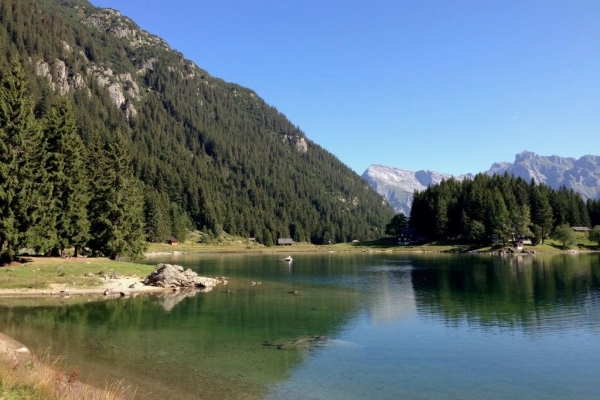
top-left (0, 235), bottom-right (598, 289)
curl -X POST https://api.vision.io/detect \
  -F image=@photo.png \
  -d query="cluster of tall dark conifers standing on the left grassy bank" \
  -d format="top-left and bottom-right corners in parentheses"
top-left (0, 60), bottom-right (145, 261)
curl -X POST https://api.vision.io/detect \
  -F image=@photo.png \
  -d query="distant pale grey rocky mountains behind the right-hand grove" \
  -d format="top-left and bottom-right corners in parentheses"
top-left (362, 151), bottom-right (600, 216)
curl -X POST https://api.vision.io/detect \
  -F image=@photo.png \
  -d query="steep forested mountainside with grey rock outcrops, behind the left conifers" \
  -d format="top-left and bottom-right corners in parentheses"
top-left (0, 0), bottom-right (392, 252)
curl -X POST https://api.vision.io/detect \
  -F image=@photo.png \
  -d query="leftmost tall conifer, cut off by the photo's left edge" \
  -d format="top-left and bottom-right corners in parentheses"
top-left (0, 59), bottom-right (55, 258)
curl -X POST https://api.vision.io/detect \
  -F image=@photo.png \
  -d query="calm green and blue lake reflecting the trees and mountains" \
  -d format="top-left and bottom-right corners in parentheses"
top-left (0, 253), bottom-right (600, 400)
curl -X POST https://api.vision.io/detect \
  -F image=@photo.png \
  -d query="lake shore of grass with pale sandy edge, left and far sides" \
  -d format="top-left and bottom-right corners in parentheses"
top-left (0, 238), bottom-right (598, 298)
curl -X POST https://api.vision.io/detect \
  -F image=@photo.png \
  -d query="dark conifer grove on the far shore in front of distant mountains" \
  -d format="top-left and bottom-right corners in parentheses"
top-left (409, 174), bottom-right (600, 243)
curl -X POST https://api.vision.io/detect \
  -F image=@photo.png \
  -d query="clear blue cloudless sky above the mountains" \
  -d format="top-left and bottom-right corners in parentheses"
top-left (92, 0), bottom-right (600, 175)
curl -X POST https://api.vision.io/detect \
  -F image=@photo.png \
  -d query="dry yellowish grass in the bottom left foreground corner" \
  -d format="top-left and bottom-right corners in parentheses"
top-left (0, 352), bottom-right (135, 400)
